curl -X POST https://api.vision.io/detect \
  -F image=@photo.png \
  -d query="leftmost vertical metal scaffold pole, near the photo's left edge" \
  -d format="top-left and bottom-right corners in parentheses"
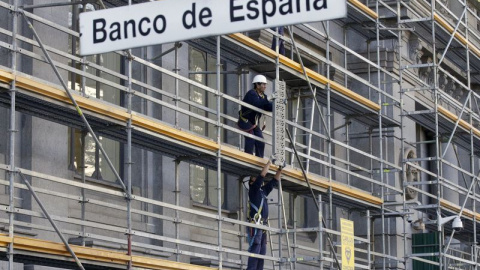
top-left (8, 0), bottom-right (18, 270)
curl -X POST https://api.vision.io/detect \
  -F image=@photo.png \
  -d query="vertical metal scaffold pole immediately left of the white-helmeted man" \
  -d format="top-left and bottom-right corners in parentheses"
top-left (216, 36), bottom-right (223, 270)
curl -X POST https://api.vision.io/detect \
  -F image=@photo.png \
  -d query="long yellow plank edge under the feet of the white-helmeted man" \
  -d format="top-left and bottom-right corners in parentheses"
top-left (0, 70), bottom-right (383, 205)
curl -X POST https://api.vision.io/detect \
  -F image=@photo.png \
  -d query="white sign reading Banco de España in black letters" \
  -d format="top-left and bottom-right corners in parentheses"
top-left (79, 0), bottom-right (347, 55)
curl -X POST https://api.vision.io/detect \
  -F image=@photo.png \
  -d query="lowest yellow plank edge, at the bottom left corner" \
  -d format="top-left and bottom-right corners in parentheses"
top-left (0, 235), bottom-right (216, 270)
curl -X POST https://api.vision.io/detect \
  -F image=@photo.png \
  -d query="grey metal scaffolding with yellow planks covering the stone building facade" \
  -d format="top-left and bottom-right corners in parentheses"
top-left (0, 0), bottom-right (480, 269)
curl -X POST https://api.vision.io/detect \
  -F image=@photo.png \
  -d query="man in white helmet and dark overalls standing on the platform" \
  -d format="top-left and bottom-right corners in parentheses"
top-left (237, 75), bottom-right (273, 157)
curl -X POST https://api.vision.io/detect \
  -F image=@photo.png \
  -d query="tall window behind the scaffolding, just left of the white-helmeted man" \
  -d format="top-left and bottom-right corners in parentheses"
top-left (189, 48), bottom-right (226, 208)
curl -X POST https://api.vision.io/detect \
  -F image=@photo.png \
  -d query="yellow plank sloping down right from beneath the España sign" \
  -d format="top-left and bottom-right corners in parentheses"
top-left (229, 33), bottom-right (380, 111)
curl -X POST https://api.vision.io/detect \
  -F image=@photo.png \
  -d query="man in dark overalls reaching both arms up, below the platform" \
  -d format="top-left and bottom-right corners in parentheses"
top-left (247, 160), bottom-right (282, 270)
